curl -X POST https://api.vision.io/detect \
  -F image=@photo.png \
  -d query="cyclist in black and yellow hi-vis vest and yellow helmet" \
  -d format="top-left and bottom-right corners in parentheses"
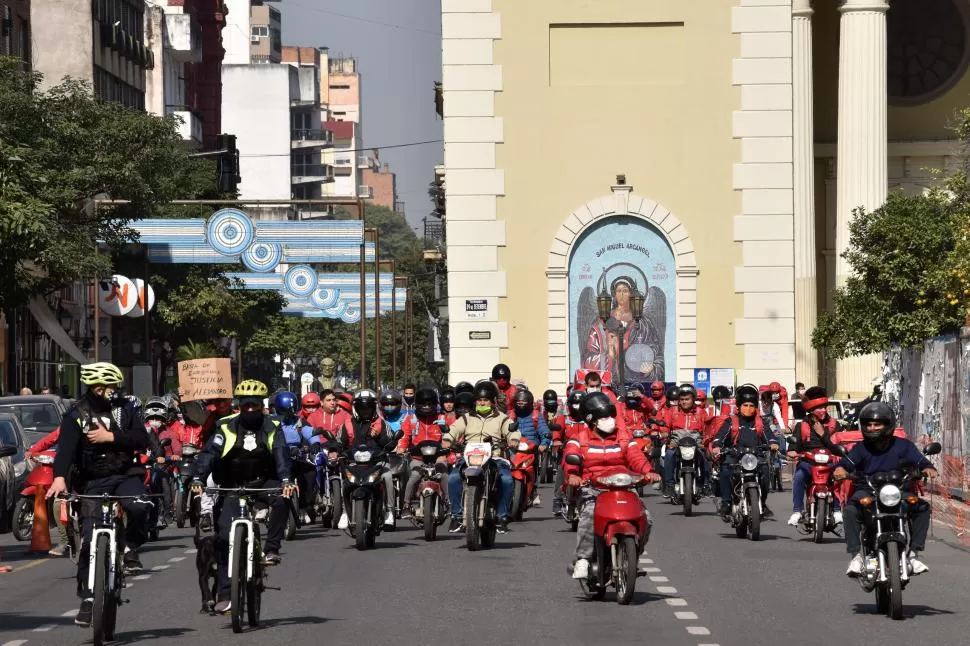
top-left (192, 379), bottom-right (296, 613)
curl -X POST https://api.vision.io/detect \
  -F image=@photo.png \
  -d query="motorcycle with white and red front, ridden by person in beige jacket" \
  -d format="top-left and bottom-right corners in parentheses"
top-left (462, 442), bottom-right (502, 552)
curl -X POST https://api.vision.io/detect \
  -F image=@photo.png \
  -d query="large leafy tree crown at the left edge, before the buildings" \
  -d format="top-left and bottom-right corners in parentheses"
top-left (0, 58), bottom-right (215, 309)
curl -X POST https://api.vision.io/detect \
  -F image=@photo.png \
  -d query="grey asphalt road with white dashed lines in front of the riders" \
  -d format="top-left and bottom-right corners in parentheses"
top-left (0, 487), bottom-right (970, 646)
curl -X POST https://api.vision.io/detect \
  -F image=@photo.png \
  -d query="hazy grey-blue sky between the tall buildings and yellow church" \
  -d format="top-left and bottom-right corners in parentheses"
top-left (274, 0), bottom-right (444, 235)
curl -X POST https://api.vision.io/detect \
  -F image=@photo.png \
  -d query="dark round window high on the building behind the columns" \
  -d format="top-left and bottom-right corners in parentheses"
top-left (886, 0), bottom-right (970, 105)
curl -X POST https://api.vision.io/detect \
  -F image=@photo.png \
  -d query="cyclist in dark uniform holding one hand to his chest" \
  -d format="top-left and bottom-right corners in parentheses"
top-left (47, 362), bottom-right (149, 626)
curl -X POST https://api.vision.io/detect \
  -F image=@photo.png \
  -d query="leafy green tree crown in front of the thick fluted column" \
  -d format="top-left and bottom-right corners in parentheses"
top-left (812, 190), bottom-right (970, 358)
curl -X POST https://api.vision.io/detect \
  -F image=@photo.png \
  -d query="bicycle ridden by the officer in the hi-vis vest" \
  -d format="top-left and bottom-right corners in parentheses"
top-left (205, 487), bottom-right (300, 633)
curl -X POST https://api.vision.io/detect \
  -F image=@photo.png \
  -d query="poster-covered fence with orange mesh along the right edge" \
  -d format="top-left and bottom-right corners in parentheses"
top-left (883, 328), bottom-right (970, 548)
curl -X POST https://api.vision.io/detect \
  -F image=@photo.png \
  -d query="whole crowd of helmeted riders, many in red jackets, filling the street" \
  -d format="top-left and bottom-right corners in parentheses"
top-left (31, 362), bottom-right (936, 625)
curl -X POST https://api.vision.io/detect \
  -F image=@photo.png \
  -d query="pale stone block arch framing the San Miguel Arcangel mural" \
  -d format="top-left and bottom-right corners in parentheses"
top-left (546, 185), bottom-right (698, 392)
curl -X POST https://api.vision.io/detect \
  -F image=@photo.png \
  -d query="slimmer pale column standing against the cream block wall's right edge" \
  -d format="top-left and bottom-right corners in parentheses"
top-left (792, 0), bottom-right (820, 384)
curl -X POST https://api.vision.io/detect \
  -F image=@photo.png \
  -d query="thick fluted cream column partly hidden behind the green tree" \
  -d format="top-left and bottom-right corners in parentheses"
top-left (835, 0), bottom-right (889, 394)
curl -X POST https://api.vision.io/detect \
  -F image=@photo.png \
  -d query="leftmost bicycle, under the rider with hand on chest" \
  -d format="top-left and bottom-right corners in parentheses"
top-left (59, 493), bottom-right (161, 646)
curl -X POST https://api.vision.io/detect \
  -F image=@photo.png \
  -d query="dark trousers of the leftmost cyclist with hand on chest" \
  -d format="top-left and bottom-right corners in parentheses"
top-left (77, 475), bottom-right (147, 599)
